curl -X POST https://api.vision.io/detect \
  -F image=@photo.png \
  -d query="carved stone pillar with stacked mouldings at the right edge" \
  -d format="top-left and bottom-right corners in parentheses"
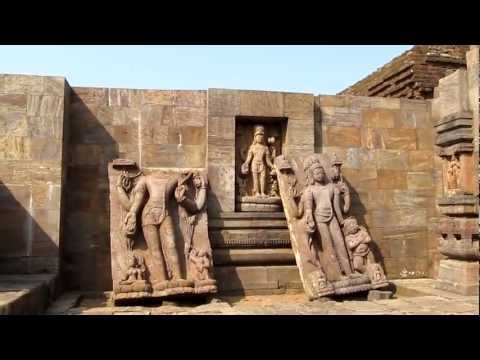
top-left (432, 49), bottom-right (480, 295)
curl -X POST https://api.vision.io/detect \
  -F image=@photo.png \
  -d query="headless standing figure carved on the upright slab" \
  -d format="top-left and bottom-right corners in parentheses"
top-left (125, 175), bottom-right (188, 290)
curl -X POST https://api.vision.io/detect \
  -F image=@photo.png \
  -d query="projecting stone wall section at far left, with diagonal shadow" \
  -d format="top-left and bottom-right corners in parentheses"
top-left (0, 75), bottom-right (70, 274)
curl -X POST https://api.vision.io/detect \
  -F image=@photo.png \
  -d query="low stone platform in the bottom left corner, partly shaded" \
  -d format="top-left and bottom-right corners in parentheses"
top-left (0, 274), bottom-right (56, 315)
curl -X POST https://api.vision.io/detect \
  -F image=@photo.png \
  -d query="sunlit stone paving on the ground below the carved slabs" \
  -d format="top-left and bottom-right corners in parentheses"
top-left (47, 279), bottom-right (479, 315)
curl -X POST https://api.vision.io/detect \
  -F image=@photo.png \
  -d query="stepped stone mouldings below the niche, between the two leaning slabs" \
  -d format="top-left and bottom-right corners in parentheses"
top-left (208, 212), bottom-right (303, 294)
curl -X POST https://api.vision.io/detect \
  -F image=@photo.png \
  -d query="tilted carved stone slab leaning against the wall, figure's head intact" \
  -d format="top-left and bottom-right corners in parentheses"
top-left (275, 154), bottom-right (389, 300)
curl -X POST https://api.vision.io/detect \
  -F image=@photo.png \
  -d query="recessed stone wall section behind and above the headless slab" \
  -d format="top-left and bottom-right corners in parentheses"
top-left (62, 87), bottom-right (207, 290)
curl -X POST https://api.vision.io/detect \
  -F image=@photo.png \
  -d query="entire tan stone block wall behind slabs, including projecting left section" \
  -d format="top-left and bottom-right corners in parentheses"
top-left (0, 75), bottom-right (442, 290)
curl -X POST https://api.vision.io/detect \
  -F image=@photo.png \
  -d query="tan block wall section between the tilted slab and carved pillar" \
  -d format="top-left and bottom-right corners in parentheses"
top-left (315, 96), bottom-right (442, 279)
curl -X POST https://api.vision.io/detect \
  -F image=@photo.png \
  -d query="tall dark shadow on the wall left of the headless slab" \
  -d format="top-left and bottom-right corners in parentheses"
top-left (61, 93), bottom-right (119, 291)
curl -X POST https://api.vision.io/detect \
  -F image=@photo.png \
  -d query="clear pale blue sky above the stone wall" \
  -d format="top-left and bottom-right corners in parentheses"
top-left (0, 45), bottom-right (412, 95)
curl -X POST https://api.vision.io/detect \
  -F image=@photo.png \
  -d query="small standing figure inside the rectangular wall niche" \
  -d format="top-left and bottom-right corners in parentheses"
top-left (241, 125), bottom-right (274, 197)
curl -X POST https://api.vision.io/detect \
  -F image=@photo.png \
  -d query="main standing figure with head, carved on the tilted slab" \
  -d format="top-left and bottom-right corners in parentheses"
top-left (303, 158), bottom-right (352, 278)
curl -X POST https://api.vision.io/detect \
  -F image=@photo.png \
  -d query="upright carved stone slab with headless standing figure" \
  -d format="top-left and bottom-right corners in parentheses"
top-left (108, 159), bottom-right (217, 301)
